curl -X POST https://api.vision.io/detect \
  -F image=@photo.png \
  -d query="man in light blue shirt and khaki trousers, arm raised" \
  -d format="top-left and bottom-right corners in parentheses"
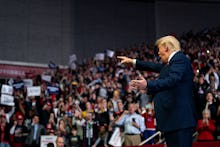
top-left (115, 103), bottom-right (145, 146)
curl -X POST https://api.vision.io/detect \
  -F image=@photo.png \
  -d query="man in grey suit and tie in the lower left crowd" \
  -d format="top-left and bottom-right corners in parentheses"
top-left (26, 114), bottom-right (46, 147)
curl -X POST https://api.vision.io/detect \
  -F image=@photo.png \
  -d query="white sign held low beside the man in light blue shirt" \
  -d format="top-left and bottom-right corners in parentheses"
top-left (108, 127), bottom-right (122, 147)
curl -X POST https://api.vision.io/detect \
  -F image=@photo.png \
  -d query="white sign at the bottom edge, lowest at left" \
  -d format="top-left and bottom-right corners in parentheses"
top-left (40, 135), bottom-right (57, 147)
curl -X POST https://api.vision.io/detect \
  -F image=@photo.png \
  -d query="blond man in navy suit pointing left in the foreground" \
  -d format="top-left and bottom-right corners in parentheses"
top-left (118, 36), bottom-right (196, 147)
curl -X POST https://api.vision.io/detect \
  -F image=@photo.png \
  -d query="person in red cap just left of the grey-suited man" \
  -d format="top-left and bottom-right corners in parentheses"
top-left (10, 114), bottom-right (28, 147)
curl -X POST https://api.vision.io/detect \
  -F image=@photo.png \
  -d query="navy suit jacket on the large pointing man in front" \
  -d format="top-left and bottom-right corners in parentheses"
top-left (136, 52), bottom-right (196, 132)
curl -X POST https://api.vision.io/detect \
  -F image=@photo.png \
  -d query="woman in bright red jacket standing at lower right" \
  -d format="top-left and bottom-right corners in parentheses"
top-left (196, 109), bottom-right (216, 141)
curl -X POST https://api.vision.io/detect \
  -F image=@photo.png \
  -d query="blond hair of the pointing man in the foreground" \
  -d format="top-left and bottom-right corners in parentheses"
top-left (155, 36), bottom-right (180, 51)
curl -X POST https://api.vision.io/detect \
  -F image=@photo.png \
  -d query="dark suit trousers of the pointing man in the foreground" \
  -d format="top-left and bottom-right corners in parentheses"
top-left (164, 127), bottom-right (193, 147)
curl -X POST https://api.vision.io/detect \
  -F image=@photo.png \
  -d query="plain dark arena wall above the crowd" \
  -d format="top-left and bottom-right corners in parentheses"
top-left (0, 0), bottom-right (220, 64)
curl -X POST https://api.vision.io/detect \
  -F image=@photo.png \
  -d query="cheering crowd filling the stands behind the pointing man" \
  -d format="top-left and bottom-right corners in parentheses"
top-left (0, 28), bottom-right (220, 147)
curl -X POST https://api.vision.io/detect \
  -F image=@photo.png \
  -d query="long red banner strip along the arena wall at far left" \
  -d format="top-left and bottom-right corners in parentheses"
top-left (0, 64), bottom-right (49, 78)
